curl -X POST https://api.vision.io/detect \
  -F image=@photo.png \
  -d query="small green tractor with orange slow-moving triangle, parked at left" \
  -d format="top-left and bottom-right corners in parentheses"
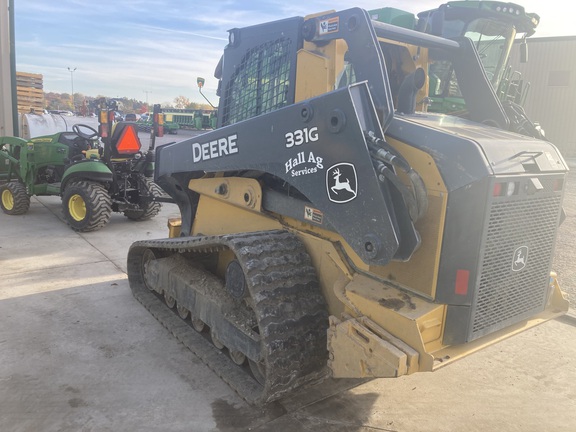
top-left (0, 100), bottom-right (162, 232)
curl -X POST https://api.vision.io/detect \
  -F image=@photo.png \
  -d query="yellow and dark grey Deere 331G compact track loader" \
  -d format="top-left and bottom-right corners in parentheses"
top-left (127, 8), bottom-right (568, 404)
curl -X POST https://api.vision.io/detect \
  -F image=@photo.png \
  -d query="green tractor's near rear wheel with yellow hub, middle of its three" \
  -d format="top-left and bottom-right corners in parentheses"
top-left (62, 180), bottom-right (112, 232)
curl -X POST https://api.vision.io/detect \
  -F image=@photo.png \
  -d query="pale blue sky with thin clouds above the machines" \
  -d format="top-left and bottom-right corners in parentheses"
top-left (14, 0), bottom-right (576, 105)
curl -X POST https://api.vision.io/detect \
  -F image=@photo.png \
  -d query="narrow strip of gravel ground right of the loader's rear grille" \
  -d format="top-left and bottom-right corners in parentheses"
top-left (552, 167), bottom-right (576, 315)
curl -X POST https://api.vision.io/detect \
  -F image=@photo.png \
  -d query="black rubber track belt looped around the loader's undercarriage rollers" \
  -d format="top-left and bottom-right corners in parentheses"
top-left (128, 231), bottom-right (328, 405)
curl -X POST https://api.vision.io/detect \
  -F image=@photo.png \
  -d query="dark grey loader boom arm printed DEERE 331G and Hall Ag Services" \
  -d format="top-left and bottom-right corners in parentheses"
top-left (155, 82), bottom-right (418, 265)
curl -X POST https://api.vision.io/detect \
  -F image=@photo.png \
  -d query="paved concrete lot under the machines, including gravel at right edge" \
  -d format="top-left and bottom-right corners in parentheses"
top-left (0, 122), bottom-right (576, 432)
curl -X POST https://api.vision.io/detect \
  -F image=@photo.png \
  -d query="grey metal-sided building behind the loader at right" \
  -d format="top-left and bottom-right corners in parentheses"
top-left (510, 36), bottom-right (576, 156)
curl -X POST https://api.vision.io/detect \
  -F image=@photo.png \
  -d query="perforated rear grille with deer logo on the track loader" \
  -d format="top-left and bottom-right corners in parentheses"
top-left (468, 186), bottom-right (562, 340)
